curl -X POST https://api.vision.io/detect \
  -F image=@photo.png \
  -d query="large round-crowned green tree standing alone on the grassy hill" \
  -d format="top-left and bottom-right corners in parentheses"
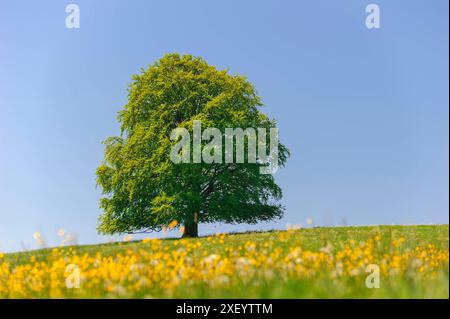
top-left (96, 54), bottom-right (289, 237)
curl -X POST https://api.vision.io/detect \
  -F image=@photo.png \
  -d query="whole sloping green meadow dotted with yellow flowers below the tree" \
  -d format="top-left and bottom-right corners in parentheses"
top-left (0, 225), bottom-right (449, 298)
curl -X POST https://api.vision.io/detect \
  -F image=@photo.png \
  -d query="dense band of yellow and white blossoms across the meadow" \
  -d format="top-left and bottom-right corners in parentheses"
top-left (0, 230), bottom-right (449, 298)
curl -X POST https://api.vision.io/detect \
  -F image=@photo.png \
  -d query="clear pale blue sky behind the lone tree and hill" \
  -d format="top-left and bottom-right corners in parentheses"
top-left (0, 0), bottom-right (449, 251)
